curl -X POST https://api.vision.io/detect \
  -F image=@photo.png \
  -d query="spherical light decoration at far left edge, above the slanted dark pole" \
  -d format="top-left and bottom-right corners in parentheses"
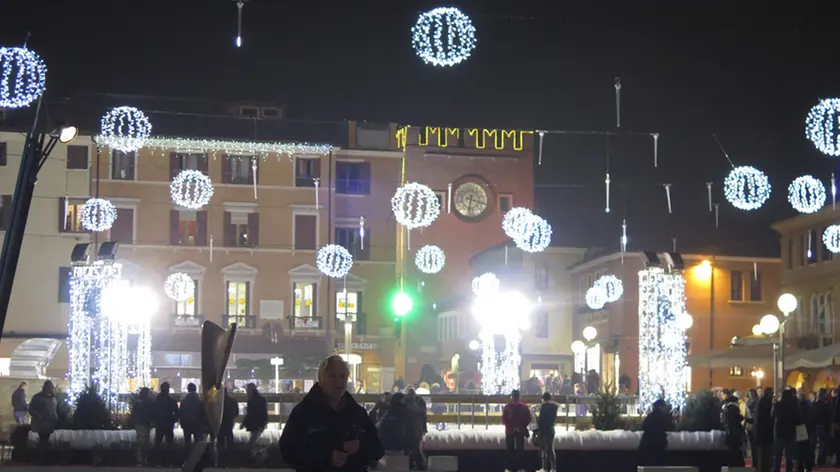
top-left (0, 48), bottom-right (47, 108)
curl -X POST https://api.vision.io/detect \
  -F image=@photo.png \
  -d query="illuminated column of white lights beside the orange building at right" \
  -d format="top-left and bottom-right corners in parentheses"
top-left (639, 267), bottom-right (686, 410)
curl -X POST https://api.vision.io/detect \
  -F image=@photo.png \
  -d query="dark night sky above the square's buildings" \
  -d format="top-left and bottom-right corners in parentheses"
top-left (0, 0), bottom-right (840, 255)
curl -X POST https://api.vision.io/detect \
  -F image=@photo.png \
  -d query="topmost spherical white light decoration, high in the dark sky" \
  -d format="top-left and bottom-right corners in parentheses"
top-left (411, 7), bottom-right (475, 67)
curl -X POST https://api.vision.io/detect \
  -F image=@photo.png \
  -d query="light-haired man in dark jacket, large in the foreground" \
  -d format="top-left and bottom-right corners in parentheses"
top-left (280, 356), bottom-right (385, 472)
